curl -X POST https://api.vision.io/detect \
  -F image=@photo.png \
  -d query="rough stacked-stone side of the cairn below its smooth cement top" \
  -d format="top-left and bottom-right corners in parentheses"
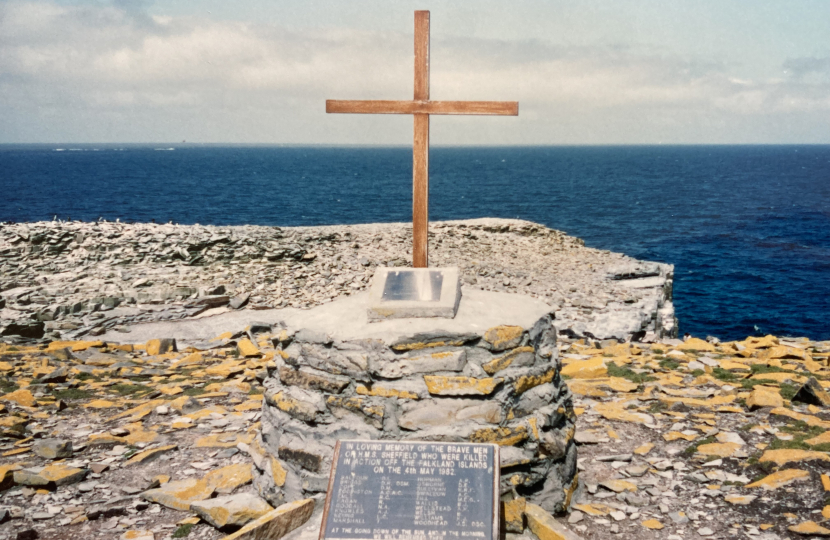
top-left (250, 315), bottom-right (577, 512)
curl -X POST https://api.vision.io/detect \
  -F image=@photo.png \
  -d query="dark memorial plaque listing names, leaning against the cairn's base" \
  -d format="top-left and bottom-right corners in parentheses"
top-left (320, 441), bottom-right (499, 540)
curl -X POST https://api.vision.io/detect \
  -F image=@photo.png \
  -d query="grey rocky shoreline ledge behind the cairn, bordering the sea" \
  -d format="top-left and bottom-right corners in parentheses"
top-left (0, 218), bottom-right (677, 343)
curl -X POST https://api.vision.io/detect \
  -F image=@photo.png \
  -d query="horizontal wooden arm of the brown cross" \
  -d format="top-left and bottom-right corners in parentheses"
top-left (326, 99), bottom-right (519, 116)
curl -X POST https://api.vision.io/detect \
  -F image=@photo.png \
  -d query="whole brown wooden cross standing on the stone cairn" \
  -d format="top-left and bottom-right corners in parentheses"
top-left (326, 11), bottom-right (519, 268)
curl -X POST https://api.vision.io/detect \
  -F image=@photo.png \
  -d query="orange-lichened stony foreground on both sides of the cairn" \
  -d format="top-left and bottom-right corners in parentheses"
top-left (0, 327), bottom-right (830, 540)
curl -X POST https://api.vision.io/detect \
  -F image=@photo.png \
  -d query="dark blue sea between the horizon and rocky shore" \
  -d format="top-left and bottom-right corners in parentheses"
top-left (0, 144), bottom-right (830, 339)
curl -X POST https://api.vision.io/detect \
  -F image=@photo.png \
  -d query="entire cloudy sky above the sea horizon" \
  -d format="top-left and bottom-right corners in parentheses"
top-left (0, 0), bottom-right (830, 145)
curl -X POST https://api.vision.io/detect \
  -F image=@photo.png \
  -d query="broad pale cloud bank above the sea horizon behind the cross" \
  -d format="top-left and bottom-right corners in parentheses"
top-left (0, 1), bottom-right (830, 143)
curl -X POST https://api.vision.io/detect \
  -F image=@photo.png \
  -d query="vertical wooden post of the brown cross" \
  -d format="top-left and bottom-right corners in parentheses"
top-left (412, 11), bottom-right (429, 268)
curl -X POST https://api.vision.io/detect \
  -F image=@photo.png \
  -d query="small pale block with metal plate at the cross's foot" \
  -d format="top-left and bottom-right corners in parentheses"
top-left (369, 268), bottom-right (461, 320)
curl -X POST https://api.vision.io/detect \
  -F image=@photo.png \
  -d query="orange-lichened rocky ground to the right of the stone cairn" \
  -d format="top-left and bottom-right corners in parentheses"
top-left (561, 336), bottom-right (830, 540)
